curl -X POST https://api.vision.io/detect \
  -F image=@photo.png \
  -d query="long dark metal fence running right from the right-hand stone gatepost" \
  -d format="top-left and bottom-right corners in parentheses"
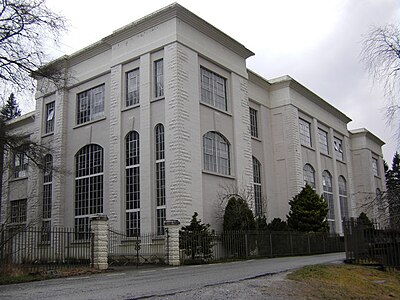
top-left (180, 231), bottom-right (344, 264)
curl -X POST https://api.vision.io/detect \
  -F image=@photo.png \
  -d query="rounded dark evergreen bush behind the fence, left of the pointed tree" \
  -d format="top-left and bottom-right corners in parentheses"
top-left (223, 196), bottom-right (256, 231)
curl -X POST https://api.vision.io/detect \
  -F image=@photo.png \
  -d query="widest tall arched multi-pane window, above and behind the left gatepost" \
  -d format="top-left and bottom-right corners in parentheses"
top-left (75, 144), bottom-right (103, 239)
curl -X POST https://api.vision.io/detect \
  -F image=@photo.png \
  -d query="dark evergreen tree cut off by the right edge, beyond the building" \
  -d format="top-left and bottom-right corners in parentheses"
top-left (385, 152), bottom-right (400, 229)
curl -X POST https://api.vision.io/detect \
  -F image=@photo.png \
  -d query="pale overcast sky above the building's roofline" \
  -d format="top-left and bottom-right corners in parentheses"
top-left (43, 0), bottom-right (400, 162)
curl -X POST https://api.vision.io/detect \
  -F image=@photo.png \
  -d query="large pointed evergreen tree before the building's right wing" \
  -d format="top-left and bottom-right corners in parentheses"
top-left (287, 184), bottom-right (329, 232)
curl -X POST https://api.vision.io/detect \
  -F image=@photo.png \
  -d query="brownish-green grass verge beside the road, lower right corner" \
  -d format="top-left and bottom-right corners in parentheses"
top-left (288, 265), bottom-right (400, 299)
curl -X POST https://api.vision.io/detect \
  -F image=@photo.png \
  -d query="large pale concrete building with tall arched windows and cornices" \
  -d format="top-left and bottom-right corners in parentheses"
top-left (2, 4), bottom-right (385, 235)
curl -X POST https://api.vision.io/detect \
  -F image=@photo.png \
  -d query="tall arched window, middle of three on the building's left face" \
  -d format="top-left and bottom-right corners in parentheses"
top-left (125, 131), bottom-right (140, 236)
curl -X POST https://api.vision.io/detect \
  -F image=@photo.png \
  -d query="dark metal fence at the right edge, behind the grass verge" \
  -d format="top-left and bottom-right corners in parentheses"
top-left (343, 219), bottom-right (400, 268)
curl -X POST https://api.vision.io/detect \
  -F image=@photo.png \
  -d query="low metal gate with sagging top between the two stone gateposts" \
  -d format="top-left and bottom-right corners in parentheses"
top-left (108, 228), bottom-right (167, 266)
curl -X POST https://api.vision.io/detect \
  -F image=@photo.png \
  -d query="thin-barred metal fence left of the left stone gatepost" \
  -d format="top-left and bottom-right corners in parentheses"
top-left (0, 227), bottom-right (93, 271)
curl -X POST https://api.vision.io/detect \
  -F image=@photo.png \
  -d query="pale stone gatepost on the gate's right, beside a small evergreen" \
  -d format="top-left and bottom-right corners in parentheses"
top-left (164, 220), bottom-right (181, 266)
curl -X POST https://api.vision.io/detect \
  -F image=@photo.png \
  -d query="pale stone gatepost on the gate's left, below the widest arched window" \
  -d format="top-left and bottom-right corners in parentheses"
top-left (90, 215), bottom-right (108, 270)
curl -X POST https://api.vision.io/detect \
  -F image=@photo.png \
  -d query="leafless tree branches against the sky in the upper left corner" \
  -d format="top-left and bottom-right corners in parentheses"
top-left (0, 0), bottom-right (66, 102)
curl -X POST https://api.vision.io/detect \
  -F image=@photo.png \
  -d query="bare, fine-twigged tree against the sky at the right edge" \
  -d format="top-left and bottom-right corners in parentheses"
top-left (361, 24), bottom-right (400, 139)
